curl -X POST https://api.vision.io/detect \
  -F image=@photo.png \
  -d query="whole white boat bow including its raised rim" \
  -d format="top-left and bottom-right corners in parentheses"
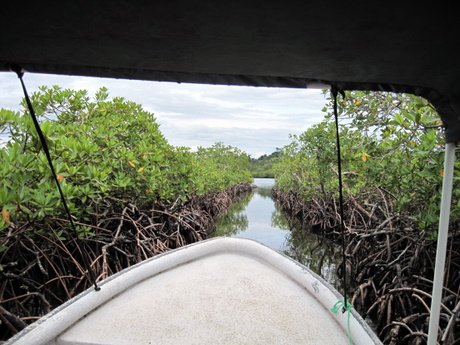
top-left (7, 238), bottom-right (380, 345)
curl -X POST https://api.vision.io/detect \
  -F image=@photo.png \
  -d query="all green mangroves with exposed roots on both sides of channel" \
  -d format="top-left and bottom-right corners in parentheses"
top-left (0, 87), bottom-right (460, 345)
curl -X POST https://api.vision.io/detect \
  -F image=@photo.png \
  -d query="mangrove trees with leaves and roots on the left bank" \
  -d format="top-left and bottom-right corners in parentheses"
top-left (0, 86), bottom-right (252, 338)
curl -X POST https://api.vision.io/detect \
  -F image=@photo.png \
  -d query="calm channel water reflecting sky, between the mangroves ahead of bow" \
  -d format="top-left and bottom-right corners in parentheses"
top-left (216, 179), bottom-right (341, 291)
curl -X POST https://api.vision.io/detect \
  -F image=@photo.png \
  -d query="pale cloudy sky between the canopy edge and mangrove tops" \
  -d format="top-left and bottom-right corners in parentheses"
top-left (0, 73), bottom-right (326, 158)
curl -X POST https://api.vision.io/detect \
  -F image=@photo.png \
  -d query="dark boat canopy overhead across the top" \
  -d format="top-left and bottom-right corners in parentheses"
top-left (0, 0), bottom-right (460, 142)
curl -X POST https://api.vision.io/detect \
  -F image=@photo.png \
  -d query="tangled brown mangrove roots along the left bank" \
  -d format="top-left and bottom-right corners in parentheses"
top-left (0, 183), bottom-right (253, 340)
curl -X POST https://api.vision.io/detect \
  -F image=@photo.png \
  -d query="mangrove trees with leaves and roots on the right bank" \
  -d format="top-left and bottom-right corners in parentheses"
top-left (274, 91), bottom-right (460, 344)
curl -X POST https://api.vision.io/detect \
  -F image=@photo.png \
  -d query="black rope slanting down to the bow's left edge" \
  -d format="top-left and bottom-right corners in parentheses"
top-left (10, 66), bottom-right (101, 291)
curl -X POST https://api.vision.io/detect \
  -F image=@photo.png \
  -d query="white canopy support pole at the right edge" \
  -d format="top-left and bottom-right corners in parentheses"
top-left (428, 143), bottom-right (455, 345)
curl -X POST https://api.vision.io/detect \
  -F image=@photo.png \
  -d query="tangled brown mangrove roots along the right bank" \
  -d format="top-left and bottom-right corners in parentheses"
top-left (274, 189), bottom-right (460, 345)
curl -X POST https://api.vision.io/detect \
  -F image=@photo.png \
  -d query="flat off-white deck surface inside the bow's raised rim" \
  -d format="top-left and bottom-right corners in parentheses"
top-left (60, 253), bottom-right (348, 345)
